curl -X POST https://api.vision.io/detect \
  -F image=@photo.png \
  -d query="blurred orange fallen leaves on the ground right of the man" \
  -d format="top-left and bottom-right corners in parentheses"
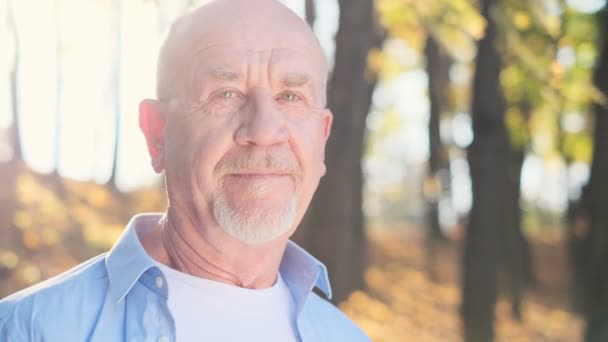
top-left (340, 230), bottom-right (583, 342)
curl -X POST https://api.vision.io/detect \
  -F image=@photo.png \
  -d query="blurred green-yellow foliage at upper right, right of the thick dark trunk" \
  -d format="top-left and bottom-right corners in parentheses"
top-left (495, 0), bottom-right (603, 163)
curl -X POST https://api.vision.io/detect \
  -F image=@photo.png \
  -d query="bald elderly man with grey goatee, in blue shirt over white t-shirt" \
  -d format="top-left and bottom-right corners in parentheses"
top-left (0, 0), bottom-right (367, 342)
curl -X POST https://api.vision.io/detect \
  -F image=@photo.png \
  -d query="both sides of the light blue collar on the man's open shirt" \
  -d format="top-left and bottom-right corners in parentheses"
top-left (105, 214), bottom-right (331, 309)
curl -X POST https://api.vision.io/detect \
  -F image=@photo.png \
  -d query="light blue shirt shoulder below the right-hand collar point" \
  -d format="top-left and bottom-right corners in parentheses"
top-left (304, 292), bottom-right (370, 341)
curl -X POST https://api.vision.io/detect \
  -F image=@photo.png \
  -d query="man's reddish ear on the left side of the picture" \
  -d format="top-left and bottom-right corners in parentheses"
top-left (139, 99), bottom-right (165, 173)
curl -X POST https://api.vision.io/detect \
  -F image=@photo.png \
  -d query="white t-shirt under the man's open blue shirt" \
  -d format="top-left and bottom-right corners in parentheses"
top-left (158, 263), bottom-right (298, 342)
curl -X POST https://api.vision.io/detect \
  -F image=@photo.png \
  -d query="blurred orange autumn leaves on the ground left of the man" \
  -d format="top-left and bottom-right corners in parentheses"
top-left (0, 171), bottom-right (166, 297)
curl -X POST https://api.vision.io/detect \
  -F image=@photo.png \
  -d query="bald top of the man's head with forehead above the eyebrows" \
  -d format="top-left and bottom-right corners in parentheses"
top-left (157, 0), bottom-right (328, 98)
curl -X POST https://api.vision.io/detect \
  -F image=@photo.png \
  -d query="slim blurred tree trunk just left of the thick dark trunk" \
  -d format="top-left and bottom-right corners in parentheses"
top-left (424, 34), bottom-right (450, 279)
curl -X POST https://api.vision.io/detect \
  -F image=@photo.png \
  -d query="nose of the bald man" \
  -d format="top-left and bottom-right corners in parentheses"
top-left (235, 88), bottom-right (288, 147)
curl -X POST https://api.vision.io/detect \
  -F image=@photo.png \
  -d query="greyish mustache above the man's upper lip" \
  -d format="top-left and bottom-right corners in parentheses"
top-left (216, 150), bottom-right (301, 176)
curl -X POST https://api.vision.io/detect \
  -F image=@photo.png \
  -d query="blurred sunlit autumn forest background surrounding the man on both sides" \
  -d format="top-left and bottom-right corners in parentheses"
top-left (0, 0), bottom-right (608, 342)
